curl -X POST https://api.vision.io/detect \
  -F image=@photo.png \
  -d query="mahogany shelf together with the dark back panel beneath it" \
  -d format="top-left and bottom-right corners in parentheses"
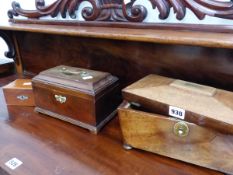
top-left (0, 13), bottom-right (233, 90)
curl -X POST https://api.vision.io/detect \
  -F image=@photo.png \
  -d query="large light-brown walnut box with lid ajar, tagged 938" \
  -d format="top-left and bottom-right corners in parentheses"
top-left (119, 75), bottom-right (233, 174)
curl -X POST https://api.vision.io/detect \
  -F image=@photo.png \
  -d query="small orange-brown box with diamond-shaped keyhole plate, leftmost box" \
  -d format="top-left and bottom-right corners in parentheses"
top-left (2, 79), bottom-right (35, 106)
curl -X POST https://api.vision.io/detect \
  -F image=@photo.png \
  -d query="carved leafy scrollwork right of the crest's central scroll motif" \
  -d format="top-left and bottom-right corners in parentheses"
top-left (150, 0), bottom-right (233, 20)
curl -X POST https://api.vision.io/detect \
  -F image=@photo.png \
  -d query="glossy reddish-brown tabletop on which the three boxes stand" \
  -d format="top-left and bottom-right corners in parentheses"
top-left (0, 76), bottom-right (223, 175)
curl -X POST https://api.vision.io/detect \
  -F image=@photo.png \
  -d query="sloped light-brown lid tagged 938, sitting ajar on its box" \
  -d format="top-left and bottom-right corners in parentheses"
top-left (123, 75), bottom-right (233, 133)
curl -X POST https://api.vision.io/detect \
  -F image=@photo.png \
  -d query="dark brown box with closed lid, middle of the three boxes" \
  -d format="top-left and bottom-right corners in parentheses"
top-left (32, 66), bottom-right (121, 133)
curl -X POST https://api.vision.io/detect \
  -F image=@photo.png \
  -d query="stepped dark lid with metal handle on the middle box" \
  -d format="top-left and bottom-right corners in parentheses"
top-left (33, 65), bottom-right (118, 95)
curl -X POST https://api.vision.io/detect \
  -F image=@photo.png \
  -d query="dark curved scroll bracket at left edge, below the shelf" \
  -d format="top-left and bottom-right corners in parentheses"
top-left (0, 31), bottom-right (15, 59)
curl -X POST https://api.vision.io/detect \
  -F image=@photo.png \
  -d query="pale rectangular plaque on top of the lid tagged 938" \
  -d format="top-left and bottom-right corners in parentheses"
top-left (170, 80), bottom-right (216, 96)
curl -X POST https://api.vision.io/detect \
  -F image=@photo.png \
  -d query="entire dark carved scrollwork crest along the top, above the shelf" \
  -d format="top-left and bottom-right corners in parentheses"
top-left (8, 0), bottom-right (233, 22)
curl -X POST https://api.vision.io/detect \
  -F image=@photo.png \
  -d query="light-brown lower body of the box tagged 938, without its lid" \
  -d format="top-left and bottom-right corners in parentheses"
top-left (119, 104), bottom-right (233, 174)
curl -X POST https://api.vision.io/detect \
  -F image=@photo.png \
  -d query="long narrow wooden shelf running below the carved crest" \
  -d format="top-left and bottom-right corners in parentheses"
top-left (0, 22), bottom-right (233, 48)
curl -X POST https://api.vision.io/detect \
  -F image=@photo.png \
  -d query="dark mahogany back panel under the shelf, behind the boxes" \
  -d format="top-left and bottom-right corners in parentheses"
top-left (16, 32), bottom-right (233, 90)
